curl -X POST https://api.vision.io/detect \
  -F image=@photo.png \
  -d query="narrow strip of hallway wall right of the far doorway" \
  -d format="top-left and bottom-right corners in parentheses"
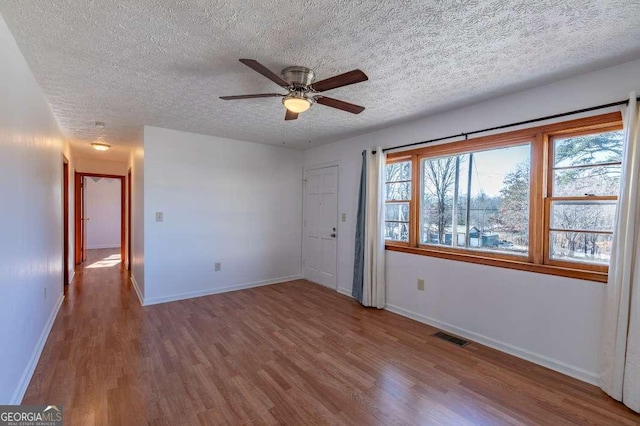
top-left (125, 138), bottom-right (145, 303)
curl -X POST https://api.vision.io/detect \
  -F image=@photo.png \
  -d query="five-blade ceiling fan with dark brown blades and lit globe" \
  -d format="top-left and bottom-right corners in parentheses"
top-left (220, 59), bottom-right (369, 120)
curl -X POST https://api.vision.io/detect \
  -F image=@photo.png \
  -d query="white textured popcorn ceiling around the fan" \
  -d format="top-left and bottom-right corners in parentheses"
top-left (0, 0), bottom-right (640, 156)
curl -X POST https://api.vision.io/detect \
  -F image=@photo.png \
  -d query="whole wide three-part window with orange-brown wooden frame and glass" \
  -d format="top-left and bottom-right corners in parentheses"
top-left (385, 113), bottom-right (622, 281)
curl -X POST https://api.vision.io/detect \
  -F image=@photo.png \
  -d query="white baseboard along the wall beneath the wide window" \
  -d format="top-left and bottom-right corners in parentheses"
top-left (385, 304), bottom-right (600, 386)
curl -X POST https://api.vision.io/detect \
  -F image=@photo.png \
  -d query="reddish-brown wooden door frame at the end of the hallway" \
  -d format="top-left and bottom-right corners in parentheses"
top-left (74, 171), bottom-right (126, 265)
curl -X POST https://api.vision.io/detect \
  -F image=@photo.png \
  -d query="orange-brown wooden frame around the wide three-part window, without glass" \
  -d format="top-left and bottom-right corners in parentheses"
top-left (385, 112), bottom-right (622, 282)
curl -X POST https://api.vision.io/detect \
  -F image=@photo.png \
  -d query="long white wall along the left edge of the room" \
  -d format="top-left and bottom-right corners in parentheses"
top-left (0, 13), bottom-right (65, 404)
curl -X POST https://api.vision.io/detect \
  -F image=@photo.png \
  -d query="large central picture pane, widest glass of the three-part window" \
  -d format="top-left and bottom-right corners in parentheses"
top-left (420, 144), bottom-right (531, 255)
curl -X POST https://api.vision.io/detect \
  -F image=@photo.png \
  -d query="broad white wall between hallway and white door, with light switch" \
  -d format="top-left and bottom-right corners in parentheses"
top-left (144, 127), bottom-right (302, 304)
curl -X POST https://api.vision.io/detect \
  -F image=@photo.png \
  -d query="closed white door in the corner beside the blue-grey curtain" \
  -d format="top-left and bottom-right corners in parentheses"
top-left (302, 166), bottom-right (338, 290)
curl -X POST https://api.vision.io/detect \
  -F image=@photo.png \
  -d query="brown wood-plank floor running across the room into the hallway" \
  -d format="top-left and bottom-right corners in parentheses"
top-left (23, 250), bottom-right (640, 425)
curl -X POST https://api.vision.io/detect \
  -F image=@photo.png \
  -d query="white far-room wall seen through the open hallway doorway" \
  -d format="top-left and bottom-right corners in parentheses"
top-left (84, 176), bottom-right (122, 250)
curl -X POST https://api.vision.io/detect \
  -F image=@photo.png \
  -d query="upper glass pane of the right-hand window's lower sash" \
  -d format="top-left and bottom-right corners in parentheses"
top-left (551, 201), bottom-right (616, 231)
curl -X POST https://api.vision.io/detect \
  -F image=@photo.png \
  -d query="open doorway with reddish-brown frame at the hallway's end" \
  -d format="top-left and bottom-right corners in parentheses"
top-left (75, 172), bottom-right (125, 266)
